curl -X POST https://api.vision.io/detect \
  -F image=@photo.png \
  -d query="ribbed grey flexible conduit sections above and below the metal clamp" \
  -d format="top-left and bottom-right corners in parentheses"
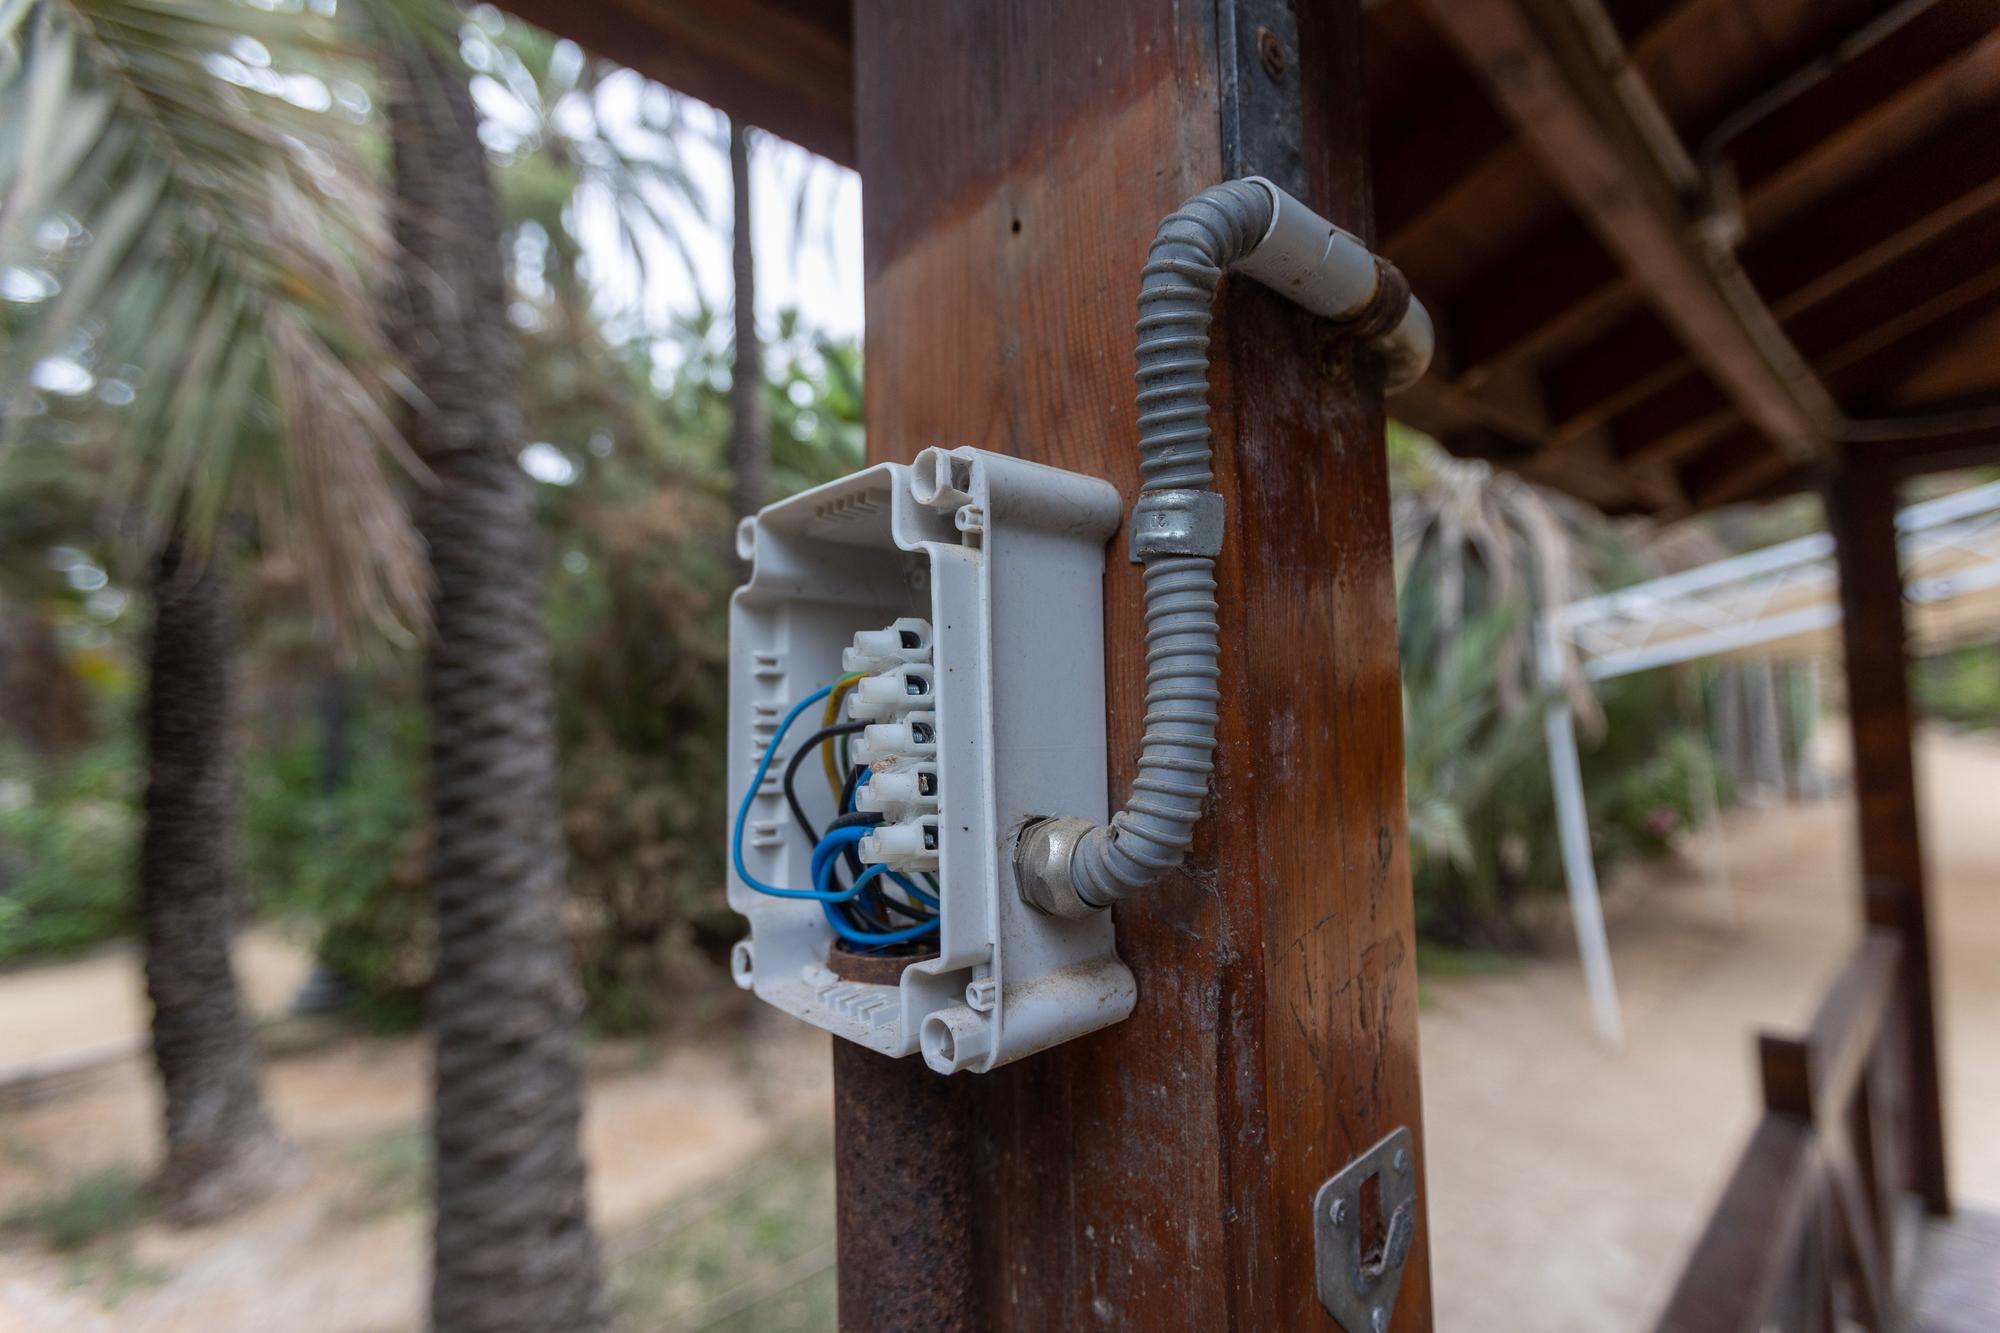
top-left (1070, 180), bottom-right (1272, 907)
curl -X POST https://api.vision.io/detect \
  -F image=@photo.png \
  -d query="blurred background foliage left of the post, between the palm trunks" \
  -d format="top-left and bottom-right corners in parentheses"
top-left (0, 10), bottom-right (862, 1016)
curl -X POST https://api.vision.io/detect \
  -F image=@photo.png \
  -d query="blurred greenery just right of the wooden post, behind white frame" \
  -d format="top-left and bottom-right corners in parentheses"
top-left (1390, 428), bottom-right (1714, 949)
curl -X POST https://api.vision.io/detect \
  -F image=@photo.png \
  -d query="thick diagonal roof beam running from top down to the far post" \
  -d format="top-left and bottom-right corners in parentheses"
top-left (1426, 0), bottom-right (1838, 458)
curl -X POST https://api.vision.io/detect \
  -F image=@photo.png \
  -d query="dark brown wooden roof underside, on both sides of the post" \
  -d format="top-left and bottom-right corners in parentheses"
top-left (512, 0), bottom-right (2000, 514)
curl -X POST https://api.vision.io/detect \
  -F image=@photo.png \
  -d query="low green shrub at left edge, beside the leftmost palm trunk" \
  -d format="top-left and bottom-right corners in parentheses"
top-left (0, 741), bottom-right (142, 963)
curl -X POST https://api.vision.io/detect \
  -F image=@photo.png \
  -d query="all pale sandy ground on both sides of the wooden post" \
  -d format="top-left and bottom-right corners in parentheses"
top-left (0, 737), bottom-right (2000, 1333)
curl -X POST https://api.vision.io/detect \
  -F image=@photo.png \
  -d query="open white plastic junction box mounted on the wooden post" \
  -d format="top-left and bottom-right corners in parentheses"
top-left (728, 448), bottom-right (1136, 1073)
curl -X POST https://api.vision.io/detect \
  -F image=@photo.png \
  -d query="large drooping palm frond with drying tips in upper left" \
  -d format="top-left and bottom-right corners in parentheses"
top-left (0, 0), bottom-right (426, 642)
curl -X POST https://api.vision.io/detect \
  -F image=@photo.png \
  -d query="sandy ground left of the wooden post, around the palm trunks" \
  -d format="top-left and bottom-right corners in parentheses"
top-left (0, 987), bottom-right (830, 1333)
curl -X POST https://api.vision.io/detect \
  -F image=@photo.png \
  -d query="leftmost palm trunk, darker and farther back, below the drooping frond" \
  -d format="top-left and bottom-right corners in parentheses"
top-left (138, 538), bottom-right (286, 1223)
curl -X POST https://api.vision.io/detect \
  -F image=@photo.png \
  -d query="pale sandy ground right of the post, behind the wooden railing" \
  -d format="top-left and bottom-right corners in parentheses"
top-left (1420, 735), bottom-right (2000, 1333)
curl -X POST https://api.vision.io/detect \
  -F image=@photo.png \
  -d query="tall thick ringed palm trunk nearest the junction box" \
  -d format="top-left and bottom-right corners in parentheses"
top-left (390, 36), bottom-right (606, 1333)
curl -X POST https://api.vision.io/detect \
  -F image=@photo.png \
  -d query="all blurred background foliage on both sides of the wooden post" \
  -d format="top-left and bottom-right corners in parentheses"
top-left (0, 10), bottom-right (2000, 1008)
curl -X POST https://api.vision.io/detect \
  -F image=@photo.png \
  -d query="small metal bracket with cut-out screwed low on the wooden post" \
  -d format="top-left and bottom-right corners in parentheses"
top-left (1312, 1125), bottom-right (1416, 1333)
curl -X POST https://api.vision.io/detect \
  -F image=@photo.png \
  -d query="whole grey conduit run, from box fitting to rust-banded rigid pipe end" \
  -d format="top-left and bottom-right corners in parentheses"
top-left (1014, 176), bottom-right (1434, 917)
